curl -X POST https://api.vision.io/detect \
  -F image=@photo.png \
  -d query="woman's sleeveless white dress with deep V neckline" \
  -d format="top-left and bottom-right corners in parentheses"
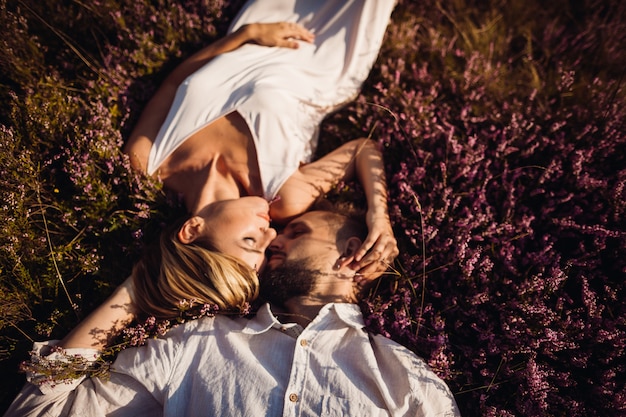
top-left (148, 0), bottom-right (395, 199)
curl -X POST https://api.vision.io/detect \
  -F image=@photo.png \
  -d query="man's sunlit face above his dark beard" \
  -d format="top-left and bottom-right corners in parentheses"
top-left (267, 211), bottom-right (340, 271)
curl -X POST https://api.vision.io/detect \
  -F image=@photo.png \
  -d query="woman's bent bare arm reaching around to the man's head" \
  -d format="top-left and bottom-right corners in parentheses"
top-left (270, 139), bottom-right (398, 277)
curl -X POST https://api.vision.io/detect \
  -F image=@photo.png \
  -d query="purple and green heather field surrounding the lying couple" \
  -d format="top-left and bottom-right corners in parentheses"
top-left (0, 0), bottom-right (626, 416)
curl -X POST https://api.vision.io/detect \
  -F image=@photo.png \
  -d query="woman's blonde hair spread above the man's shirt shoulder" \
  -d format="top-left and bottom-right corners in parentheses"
top-left (133, 219), bottom-right (259, 320)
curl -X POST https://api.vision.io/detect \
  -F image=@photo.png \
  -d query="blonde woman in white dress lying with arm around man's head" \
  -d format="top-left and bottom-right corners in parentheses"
top-left (53, 0), bottom-right (398, 348)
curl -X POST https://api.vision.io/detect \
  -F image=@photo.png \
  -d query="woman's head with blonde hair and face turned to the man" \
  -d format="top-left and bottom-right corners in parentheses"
top-left (130, 197), bottom-right (276, 320)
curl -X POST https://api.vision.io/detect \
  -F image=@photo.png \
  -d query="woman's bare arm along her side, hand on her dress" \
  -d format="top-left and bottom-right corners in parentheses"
top-left (124, 22), bottom-right (314, 171)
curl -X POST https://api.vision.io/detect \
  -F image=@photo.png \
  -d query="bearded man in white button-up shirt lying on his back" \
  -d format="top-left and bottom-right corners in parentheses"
top-left (8, 211), bottom-right (458, 417)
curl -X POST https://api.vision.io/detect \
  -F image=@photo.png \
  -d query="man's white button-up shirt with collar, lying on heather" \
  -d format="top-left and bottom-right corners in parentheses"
top-left (7, 304), bottom-right (459, 417)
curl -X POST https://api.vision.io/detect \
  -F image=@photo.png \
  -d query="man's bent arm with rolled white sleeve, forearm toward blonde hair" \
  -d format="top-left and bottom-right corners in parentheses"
top-left (5, 278), bottom-right (136, 416)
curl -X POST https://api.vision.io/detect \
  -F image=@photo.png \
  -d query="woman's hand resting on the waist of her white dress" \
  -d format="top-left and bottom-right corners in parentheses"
top-left (242, 22), bottom-right (315, 49)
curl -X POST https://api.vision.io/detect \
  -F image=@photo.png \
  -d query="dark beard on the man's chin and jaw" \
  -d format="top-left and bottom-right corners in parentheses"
top-left (259, 261), bottom-right (321, 306)
